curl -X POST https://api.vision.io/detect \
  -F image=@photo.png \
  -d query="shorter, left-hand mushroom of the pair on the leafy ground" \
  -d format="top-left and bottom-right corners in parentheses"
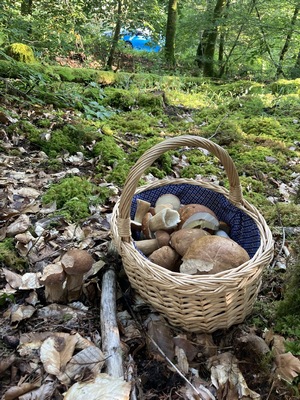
top-left (39, 262), bottom-right (66, 303)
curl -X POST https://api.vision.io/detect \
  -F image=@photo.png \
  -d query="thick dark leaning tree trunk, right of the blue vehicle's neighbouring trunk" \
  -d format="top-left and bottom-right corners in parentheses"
top-left (197, 0), bottom-right (227, 77)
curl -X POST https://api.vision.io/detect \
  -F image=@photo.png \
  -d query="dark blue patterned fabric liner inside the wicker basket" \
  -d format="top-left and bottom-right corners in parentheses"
top-left (131, 184), bottom-right (260, 258)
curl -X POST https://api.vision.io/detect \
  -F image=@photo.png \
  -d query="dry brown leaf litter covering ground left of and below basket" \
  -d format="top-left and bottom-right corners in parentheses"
top-left (0, 86), bottom-right (300, 400)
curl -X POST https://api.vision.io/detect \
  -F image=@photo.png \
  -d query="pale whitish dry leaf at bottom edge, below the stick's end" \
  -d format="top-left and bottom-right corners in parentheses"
top-left (64, 374), bottom-right (131, 400)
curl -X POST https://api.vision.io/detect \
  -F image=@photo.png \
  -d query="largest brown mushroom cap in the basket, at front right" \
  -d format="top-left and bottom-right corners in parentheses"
top-left (180, 235), bottom-right (250, 275)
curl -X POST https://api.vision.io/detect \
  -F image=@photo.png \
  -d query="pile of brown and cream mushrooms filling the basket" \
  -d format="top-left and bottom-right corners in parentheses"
top-left (131, 194), bottom-right (250, 275)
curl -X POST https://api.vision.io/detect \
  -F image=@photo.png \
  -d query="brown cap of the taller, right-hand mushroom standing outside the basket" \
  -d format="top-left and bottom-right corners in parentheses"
top-left (61, 248), bottom-right (94, 275)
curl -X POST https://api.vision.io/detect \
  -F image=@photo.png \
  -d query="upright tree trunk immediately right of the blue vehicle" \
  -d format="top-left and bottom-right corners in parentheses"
top-left (165, 0), bottom-right (178, 67)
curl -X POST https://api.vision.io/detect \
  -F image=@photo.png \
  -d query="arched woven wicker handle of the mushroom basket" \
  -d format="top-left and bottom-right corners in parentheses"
top-left (117, 135), bottom-right (243, 242)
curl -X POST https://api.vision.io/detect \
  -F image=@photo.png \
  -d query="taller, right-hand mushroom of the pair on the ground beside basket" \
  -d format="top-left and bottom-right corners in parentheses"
top-left (61, 248), bottom-right (94, 301)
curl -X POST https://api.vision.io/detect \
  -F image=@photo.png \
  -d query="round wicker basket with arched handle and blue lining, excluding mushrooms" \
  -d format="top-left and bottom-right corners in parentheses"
top-left (111, 135), bottom-right (273, 333)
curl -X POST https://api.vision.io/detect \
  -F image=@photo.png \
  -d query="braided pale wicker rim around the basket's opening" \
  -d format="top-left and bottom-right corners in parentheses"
top-left (111, 178), bottom-right (274, 285)
